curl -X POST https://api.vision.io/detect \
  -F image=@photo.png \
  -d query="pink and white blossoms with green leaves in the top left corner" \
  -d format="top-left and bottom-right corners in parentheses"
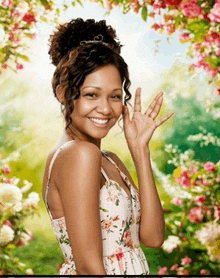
top-left (0, 0), bottom-right (53, 74)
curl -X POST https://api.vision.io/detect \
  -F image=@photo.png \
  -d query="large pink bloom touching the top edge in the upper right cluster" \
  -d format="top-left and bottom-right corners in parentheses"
top-left (179, 0), bottom-right (203, 18)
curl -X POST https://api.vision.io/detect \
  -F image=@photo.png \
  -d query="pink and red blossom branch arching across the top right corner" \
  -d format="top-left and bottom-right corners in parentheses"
top-left (100, 0), bottom-right (220, 95)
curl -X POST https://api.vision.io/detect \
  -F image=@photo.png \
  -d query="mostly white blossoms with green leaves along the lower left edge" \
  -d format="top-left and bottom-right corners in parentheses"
top-left (0, 150), bottom-right (40, 275)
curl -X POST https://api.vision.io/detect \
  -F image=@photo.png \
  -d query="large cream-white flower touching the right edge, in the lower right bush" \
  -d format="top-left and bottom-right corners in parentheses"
top-left (195, 223), bottom-right (220, 244)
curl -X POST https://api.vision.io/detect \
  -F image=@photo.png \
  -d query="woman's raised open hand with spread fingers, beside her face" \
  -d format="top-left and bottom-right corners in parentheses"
top-left (123, 88), bottom-right (174, 147)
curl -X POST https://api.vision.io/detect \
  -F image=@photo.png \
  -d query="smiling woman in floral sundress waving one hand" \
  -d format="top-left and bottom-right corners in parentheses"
top-left (42, 18), bottom-right (173, 275)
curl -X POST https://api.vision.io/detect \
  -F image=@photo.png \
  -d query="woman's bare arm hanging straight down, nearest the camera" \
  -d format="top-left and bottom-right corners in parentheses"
top-left (55, 142), bottom-right (107, 275)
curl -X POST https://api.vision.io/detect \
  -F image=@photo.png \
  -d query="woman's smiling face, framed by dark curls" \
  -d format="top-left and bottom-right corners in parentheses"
top-left (71, 64), bottom-right (123, 139)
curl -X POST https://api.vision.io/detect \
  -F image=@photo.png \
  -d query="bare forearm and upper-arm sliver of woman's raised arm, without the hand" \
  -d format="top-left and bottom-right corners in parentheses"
top-left (106, 148), bottom-right (165, 248)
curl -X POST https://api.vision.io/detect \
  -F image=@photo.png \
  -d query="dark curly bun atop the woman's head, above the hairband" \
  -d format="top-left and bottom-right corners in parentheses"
top-left (48, 18), bottom-right (121, 66)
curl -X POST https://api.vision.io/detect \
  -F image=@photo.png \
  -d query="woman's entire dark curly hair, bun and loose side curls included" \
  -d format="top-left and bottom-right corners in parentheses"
top-left (48, 18), bottom-right (131, 132)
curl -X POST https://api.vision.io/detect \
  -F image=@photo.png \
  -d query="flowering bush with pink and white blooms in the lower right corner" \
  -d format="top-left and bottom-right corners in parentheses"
top-left (155, 141), bottom-right (220, 275)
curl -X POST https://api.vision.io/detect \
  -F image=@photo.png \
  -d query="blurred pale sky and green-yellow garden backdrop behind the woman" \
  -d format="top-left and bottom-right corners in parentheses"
top-left (0, 1), bottom-right (220, 275)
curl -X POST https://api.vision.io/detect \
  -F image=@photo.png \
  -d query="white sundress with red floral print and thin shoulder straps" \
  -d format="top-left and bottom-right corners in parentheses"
top-left (44, 140), bottom-right (150, 275)
